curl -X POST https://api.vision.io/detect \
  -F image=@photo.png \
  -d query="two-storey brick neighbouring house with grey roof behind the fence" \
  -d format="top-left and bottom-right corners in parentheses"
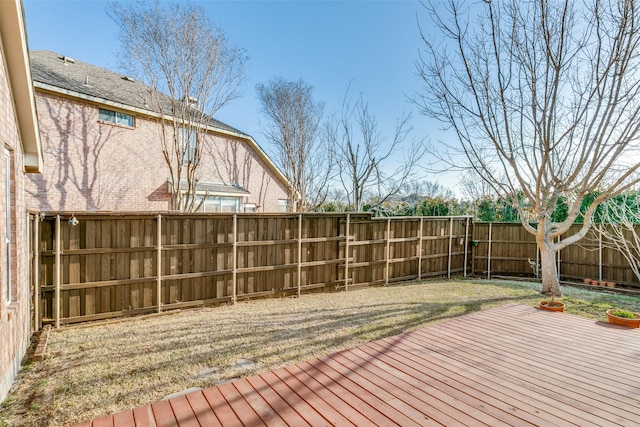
top-left (28, 51), bottom-right (288, 212)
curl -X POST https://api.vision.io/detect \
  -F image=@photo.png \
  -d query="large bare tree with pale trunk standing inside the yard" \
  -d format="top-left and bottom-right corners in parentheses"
top-left (415, 0), bottom-right (640, 295)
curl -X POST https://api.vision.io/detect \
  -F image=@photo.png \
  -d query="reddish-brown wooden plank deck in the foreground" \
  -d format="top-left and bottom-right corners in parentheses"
top-left (71, 304), bottom-right (640, 427)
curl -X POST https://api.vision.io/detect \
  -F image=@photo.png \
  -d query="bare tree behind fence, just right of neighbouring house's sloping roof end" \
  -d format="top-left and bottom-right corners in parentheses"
top-left (256, 77), bottom-right (331, 212)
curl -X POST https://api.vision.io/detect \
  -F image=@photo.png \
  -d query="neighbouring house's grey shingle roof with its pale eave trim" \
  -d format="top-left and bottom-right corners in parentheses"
top-left (29, 49), bottom-right (291, 188)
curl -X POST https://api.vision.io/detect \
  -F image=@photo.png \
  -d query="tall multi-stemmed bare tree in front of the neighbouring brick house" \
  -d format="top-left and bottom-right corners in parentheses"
top-left (109, 1), bottom-right (246, 211)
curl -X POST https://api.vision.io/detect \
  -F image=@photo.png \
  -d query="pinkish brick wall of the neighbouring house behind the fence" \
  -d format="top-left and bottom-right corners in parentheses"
top-left (27, 91), bottom-right (287, 212)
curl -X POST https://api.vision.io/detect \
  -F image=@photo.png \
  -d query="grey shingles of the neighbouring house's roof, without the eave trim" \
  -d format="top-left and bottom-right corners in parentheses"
top-left (31, 50), bottom-right (248, 136)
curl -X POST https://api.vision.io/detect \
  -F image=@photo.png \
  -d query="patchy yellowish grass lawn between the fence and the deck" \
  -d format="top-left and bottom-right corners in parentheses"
top-left (0, 280), bottom-right (640, 426)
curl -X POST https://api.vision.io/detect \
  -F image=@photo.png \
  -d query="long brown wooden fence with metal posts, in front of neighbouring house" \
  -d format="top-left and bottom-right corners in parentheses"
top-left (31, 213), bottom-right (471, 330)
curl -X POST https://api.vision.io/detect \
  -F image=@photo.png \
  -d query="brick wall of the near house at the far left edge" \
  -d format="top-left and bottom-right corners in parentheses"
top-left (0, 44), bottom-right (30, 401)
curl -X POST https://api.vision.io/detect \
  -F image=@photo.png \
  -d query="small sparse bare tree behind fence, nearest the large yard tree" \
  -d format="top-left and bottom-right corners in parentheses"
top-left (325, 90), bottom-right (424, 211)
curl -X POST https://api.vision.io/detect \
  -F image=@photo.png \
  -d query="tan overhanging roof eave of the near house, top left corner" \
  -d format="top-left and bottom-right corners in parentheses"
top-left (0, 0), bottom-right (42, 173)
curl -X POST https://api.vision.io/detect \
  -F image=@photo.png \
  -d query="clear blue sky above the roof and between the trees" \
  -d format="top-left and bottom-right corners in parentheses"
top-left (24, 0), bottom-right (456, 194)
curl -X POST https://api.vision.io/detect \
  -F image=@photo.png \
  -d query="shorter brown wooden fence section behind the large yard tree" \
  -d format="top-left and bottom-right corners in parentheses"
top-left (472, 222), bottom-right (640, 286)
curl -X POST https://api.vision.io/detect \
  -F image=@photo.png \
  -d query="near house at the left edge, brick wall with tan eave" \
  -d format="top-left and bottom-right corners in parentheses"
top-left (0, 0), bottom-right (42, 401)
